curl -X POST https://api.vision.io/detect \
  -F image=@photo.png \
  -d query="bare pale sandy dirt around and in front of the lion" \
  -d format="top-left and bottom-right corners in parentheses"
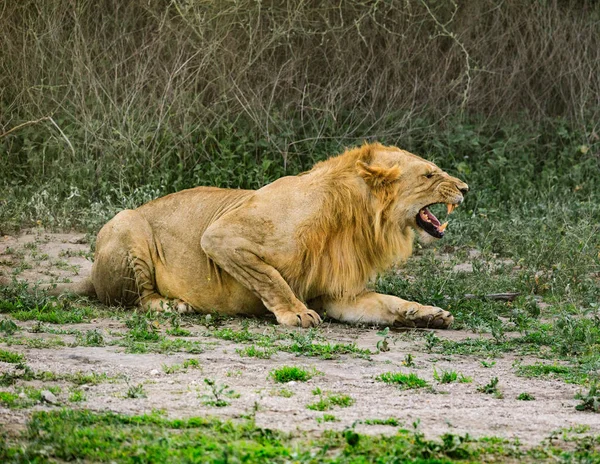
top-left (0, 231), bottom-right (600, 445)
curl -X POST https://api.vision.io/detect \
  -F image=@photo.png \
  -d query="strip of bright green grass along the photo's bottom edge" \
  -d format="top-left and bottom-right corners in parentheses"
top-left (0, 409), bottom-right (600, 464)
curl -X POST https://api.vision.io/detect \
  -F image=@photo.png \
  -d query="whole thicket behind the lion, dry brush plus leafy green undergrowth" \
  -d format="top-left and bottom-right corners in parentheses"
top-left (0, 0), bottom-right (600, 232)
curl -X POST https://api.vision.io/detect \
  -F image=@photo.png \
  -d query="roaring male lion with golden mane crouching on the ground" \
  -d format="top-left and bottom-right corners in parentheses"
top-left (50, 143), bottom-right (468, 328)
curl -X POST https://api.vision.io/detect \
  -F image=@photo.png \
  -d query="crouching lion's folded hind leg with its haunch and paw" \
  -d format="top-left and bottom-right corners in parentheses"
top-left (92, 210), bottom-right (191, 313)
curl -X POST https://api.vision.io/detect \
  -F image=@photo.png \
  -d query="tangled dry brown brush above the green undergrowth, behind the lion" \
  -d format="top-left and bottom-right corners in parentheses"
top-left (0, 0), bottom-right (600, 174)
